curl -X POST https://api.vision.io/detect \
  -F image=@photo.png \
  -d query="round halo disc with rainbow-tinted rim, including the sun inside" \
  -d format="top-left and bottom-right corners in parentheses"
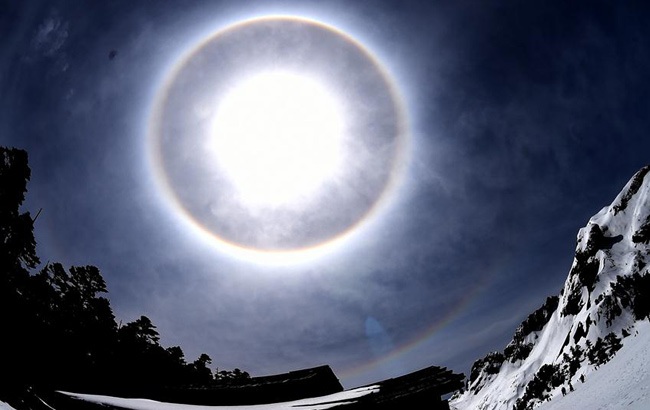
top-left (149, 16), bottom-right (407, 255)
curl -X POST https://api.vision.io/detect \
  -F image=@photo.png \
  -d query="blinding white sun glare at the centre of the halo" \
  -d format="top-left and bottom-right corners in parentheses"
top-left (207, 72), bottom-right (344, 207)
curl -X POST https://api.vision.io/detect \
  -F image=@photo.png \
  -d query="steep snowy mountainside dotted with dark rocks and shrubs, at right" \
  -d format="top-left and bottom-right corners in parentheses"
top-left (451, 166), bottom-right (650, 410)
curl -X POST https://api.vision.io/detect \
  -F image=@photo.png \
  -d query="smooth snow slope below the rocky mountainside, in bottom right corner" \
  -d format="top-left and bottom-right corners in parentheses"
top-left (536, 321), bottom-right (650, 410)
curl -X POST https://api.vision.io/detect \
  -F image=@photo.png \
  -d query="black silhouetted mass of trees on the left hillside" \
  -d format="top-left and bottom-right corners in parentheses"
top-left (0, 147), bottom-right (249, 402)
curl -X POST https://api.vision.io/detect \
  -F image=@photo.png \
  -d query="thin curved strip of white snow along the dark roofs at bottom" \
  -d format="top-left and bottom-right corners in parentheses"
top-left (59, 386), bottom-right (379, 410)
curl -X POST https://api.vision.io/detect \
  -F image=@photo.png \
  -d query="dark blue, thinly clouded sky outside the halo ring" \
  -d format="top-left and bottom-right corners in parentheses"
top-left (0, 0), bottom-right (650, 387)
